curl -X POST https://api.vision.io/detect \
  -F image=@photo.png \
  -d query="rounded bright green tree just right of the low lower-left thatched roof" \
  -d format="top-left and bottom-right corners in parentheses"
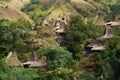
top-left (40, 47), bottom-right (73, 70)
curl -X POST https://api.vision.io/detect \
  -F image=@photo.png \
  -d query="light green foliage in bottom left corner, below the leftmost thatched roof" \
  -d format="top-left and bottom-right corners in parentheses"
top-left (0, 68), bottom-right (39, 80)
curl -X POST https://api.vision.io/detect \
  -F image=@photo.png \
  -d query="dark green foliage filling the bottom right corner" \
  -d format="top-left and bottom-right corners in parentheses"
top-left (97, 51), bottom-right (120, 80)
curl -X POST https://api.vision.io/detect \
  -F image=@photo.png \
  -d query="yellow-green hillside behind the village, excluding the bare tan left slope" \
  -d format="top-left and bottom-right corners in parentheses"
top-left (23, 0), bottom-right (118, 22)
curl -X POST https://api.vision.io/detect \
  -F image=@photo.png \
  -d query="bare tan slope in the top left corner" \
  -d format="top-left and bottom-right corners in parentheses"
top-left (0, 0), bottom-right (33, 23)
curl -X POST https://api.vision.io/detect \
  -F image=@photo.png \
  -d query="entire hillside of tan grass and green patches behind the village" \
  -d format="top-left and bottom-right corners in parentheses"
top-left (0, 0), bottom-right (119, 23)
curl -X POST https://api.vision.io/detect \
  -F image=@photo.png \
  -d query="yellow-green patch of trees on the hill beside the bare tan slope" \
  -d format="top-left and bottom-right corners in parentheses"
top-left (22, 0), bottom-right (47, 23)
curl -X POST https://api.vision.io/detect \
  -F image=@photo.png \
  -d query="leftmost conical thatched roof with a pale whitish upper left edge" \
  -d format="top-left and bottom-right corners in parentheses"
top-left (6, 52), bottom-right (23, 67)
